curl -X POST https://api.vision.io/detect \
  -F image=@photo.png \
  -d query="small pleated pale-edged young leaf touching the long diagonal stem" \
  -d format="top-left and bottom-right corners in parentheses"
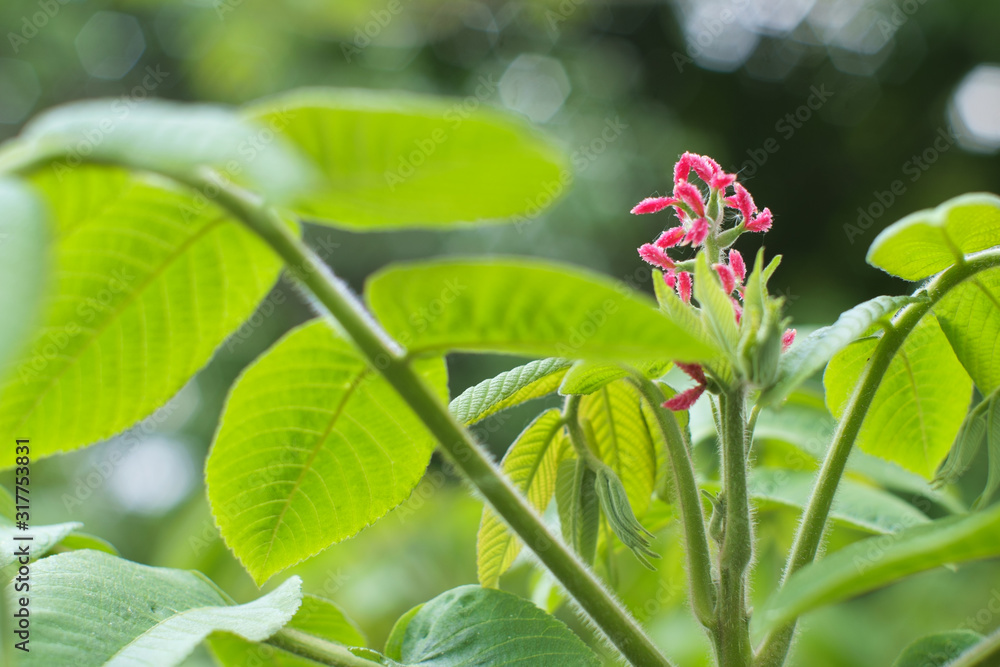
top-left (448, 358), bottom-right (573, 425)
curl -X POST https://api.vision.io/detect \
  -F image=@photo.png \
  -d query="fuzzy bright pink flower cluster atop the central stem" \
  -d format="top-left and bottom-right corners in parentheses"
top-left (632, 153), bottom-right (795, 410)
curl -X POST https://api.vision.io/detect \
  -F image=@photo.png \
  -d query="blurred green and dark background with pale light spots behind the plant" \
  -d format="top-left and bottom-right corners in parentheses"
top-left (0, 0), bottom-right (1000, 667)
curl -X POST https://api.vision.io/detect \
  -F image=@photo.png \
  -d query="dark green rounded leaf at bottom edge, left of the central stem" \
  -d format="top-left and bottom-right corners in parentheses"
top-left (390, 586), bottom-right (599, 667)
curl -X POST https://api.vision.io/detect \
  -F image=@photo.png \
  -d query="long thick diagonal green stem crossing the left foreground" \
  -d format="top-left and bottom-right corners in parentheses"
top-left (186, 172), bottom-right (671, 667)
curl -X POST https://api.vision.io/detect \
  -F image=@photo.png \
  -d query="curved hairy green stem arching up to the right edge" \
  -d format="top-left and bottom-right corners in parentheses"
top-left (755, 249), bottom-right (1000, 667)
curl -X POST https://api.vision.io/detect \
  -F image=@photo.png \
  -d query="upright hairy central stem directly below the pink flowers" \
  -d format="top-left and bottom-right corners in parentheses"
top-left (717, 388), bottom-right (753, 667)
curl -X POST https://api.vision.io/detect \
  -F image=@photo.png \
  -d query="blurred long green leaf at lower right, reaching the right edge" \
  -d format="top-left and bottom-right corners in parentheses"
top-left (760, 507), bottom-right (1000, 631)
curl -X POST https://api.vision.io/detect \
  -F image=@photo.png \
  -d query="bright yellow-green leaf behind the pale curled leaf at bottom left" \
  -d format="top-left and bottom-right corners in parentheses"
top-left (208, 595), bottom-right (368, 667)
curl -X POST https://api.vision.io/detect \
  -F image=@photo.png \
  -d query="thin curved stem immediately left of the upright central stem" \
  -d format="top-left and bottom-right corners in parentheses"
top-left (630, 372), bottom-right (716, 629)
